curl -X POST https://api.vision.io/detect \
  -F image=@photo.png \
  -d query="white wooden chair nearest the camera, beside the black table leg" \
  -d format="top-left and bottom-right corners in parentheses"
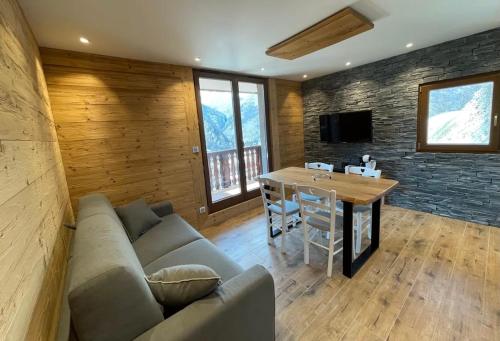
top-left (296, 186), bottom-right (343, 277)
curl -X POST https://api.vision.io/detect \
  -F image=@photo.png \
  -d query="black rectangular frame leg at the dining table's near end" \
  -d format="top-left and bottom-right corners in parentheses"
top-left (343, 200), bottom-right (381, 278)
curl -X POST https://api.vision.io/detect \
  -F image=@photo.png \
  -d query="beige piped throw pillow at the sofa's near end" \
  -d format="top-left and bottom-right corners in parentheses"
top-left (145, 264), bottom-right (221, 308)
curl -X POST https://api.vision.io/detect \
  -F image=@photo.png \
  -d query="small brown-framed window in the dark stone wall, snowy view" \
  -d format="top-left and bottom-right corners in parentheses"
top-left (417, 72), bottom-right (500, 153)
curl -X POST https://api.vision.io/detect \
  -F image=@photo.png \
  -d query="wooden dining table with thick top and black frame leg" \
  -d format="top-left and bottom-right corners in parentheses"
top-left (261, 167), bottom-right (399, 278)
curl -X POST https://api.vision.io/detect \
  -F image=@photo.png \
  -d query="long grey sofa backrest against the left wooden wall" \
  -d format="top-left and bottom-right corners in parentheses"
top-left (69, 194), bottom-right (163, 341)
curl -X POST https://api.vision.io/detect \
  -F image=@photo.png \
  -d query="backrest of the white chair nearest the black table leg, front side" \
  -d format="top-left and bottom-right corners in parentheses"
top-left (295, 185), bottom-right (337, 231)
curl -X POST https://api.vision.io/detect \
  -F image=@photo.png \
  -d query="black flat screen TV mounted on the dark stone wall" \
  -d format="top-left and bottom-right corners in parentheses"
top-left (319, 110), bottom-right (372, 143)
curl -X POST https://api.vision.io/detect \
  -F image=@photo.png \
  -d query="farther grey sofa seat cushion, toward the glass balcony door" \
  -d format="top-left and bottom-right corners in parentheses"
top-left (132, 214), bottom-right (203, 266)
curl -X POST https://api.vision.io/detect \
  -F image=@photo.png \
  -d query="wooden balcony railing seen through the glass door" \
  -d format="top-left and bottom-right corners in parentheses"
top-left (207, 146), bottom-right (262, 193)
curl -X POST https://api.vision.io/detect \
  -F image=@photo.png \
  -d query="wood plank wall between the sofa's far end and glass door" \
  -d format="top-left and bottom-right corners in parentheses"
top-left (41, 48), bottom-right (206, 226)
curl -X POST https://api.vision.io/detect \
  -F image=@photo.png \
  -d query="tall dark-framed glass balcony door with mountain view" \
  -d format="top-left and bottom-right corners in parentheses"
top-left (195, 71), bottom-right (269, 212)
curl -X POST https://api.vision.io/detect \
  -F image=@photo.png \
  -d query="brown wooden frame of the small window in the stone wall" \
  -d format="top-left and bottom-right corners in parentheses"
top-left (417, 71), bottom-right (500, 153)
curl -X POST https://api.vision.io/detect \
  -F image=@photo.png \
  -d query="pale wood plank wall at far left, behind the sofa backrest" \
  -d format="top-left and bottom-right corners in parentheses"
top-left (0, 0), bottom-right (73, 340)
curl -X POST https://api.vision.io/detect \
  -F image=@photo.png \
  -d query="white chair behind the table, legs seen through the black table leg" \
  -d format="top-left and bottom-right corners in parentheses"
top-left (344, 166), bottom-right (382, 254)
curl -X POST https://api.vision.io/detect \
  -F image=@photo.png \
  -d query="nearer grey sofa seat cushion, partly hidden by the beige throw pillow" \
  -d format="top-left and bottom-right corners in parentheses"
top-left (144, 239), bottom-right (243, 282)
